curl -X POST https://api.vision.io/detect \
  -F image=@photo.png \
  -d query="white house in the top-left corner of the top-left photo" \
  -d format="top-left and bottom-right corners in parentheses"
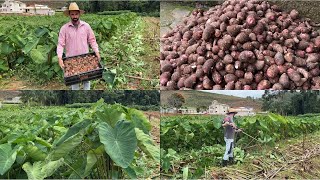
top-left (0, 0), bottom-right (26, 13)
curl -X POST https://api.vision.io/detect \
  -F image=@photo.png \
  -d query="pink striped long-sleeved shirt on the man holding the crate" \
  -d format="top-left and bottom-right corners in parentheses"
top-left (57, 21), bottom-right (99, 58)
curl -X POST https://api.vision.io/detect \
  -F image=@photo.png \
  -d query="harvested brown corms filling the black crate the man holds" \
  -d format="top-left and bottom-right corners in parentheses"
top-left (64, 55), bottom-right (99, 77)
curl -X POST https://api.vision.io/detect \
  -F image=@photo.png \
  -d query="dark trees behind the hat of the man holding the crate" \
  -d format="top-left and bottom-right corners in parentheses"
top-left (67, 0), bottom-right (160, 16)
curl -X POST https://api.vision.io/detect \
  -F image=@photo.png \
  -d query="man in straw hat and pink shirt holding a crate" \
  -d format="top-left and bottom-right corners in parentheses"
top-left (57, 2), bottom-right (100, 90)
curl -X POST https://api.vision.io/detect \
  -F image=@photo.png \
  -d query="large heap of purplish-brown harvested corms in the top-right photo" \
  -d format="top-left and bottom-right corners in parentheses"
top-left (160, 0), bottom-right (320, 90)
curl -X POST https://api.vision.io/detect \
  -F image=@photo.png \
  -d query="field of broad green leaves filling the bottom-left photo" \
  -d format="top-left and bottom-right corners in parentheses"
top-left (0, 100), bottom-right (160, 179)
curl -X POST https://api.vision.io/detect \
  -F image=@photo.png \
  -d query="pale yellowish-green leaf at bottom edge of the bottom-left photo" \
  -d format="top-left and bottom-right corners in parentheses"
top-left (22, 158), bottom-right (64, 180)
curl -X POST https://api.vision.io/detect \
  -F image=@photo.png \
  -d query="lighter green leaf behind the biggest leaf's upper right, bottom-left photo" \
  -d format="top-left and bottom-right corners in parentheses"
top-left (126, 108), bottom-right (151, 134)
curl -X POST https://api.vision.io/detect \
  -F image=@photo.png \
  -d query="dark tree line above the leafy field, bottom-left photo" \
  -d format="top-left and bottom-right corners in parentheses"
top-left (21, 90), bottom-right (160, 106)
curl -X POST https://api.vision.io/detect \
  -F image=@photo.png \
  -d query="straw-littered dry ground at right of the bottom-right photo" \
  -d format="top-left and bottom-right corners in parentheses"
top-left (209, 132), bottom-right (320, 179)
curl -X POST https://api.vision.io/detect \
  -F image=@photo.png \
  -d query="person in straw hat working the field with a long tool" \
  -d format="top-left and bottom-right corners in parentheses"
top-left (222, 111), bottom-right (241, 166)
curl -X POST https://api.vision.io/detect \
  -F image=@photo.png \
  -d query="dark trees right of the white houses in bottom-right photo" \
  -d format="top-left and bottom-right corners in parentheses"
top-left (262, 90), bottom-right (320, 115)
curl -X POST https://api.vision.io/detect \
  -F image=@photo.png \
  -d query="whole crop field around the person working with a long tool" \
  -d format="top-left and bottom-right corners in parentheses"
top-left (160, 113), bottom-right (320, 179)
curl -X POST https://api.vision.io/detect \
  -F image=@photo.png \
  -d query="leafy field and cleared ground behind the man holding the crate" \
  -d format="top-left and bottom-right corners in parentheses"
top-left (0, 13), bottom-right (160, 90)
